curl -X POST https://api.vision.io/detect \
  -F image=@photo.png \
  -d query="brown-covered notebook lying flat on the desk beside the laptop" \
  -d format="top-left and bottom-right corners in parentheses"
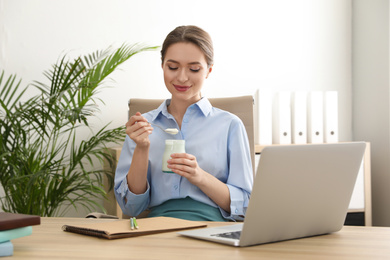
top-left (62, 217), bottom-right (207, 239)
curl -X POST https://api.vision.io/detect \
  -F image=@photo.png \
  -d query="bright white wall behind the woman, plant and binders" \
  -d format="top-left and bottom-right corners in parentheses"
top-left (0, 0), bottom-right (352, 216)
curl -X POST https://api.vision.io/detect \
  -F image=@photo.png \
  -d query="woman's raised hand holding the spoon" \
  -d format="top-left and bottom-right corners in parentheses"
top-left (126, 112), bottom-right (153, 147)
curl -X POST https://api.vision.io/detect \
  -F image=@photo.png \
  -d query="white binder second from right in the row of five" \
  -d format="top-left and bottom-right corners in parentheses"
top-left (307, 91), bottom-right (324, 143)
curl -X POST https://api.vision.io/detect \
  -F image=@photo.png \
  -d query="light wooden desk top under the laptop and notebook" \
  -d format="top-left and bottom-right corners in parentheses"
top-left (6, 218), bottom-right (390, 260)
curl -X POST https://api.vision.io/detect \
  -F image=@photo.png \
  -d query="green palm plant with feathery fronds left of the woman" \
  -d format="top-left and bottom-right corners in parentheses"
top-left (0, 44), bottom-right (157, 216)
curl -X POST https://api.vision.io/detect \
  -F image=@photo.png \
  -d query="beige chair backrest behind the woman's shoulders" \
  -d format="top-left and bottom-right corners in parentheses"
top-left (129, 95), bottom-right (255, 177)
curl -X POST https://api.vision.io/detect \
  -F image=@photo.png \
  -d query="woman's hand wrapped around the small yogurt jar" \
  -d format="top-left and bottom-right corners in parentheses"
top-left (168, 153), bottom-right (207, 186)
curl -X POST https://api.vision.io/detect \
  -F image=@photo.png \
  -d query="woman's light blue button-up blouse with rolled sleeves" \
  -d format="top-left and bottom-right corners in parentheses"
top-left (114, 98), bottom-right (253, 220)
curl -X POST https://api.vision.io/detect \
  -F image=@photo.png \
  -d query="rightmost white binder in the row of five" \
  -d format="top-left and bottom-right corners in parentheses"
top-left (324, 91), bottom-right (339, 143)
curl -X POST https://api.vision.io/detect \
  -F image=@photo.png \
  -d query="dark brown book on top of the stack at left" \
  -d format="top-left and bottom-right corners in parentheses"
top-left (0, 212), bottom-right (41, 231)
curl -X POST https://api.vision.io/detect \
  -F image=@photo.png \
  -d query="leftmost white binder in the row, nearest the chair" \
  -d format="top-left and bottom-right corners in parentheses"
top-left (254, 90), bottom-right (273, 145)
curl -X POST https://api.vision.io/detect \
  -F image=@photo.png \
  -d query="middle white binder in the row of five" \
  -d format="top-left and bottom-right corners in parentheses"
top-left (291, 91), bottom-right (307, 144)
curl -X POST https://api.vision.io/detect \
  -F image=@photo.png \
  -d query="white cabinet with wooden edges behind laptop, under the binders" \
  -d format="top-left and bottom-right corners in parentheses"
top-left (255, 143), bottom-right (372, 226)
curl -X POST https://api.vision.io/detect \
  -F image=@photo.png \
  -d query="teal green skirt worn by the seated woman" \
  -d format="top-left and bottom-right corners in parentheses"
top-left (148, 197), bottom-right (227, 221)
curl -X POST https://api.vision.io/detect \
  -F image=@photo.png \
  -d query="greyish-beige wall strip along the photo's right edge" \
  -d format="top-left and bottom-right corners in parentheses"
top-left (353, 0), bottom-right (390, 226)
